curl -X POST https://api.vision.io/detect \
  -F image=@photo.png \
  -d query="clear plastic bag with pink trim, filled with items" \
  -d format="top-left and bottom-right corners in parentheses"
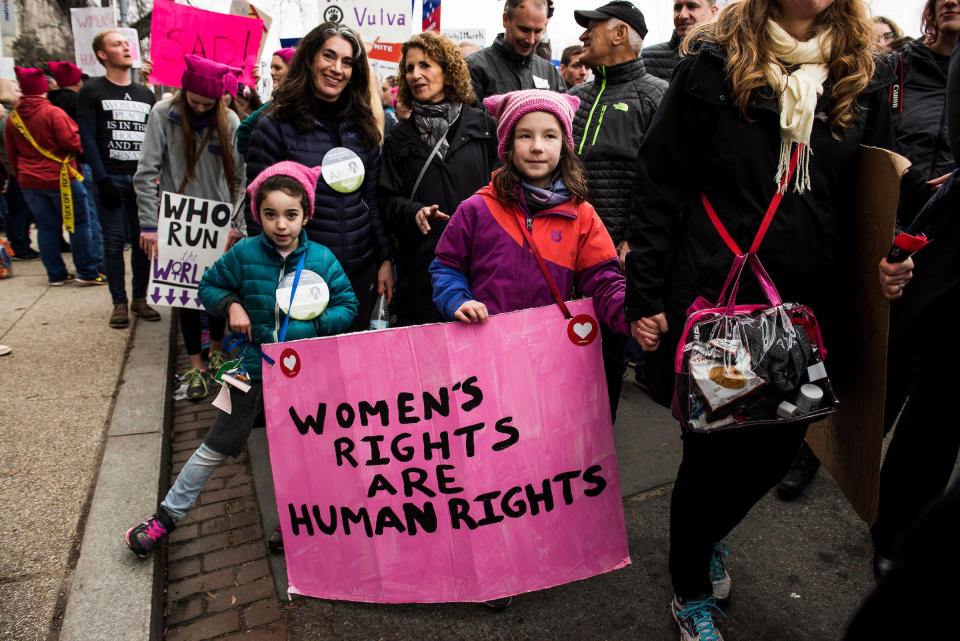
top-left (673, 255), bottom-right (838, 432)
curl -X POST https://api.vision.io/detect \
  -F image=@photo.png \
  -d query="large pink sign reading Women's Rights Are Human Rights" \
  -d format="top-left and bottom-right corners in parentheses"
top-left (263, 300), bottom-right (630, 603)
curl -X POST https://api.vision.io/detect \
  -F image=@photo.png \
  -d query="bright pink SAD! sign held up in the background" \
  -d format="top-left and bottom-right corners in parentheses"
top-left (150, 0), bottom-right (263, 87)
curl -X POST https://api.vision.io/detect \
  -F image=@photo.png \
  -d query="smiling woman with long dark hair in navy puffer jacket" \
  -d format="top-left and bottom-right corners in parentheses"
top-left (247, 22), bottom-right (393, 329)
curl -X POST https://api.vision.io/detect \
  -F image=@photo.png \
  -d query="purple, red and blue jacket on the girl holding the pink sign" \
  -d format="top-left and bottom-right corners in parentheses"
top-left (430, 180), bottom-right (628, 334)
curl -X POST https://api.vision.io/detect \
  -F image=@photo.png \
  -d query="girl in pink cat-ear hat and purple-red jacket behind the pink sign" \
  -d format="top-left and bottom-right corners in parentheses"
top-left (430, 89), bottom-right (627, 608)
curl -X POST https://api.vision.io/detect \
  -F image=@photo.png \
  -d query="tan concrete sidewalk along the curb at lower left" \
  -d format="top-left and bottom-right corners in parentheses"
top-left (0, 254), bottom-right (170, 641)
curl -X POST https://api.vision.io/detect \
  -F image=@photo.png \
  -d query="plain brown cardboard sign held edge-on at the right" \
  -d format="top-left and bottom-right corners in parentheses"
top-left (807, 147), bottom-right (910, 524)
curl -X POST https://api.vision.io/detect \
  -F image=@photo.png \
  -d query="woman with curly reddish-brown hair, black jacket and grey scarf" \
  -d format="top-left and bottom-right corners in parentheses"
top-left (380, 31), bottom-right (499, 325)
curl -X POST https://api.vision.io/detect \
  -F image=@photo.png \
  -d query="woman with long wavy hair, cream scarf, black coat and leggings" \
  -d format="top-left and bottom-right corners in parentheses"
top-left (626, 0), bottom-right (893, 641)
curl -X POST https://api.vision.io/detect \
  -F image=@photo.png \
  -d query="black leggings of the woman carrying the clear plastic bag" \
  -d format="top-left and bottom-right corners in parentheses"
top-left (670, 423), bottom-right (808, 599)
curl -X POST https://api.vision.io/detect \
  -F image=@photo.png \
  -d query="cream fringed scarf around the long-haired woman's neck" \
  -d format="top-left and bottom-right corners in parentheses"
top-left (767, 20), bottom-right (833, 194)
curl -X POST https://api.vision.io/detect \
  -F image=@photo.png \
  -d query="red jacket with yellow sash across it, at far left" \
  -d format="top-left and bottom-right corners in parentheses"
top-left (3, 96), bottom-right (83, 189)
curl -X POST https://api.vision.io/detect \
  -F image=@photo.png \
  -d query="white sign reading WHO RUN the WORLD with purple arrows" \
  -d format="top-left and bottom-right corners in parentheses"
top-left (147, 191), bottom-right (233, 309)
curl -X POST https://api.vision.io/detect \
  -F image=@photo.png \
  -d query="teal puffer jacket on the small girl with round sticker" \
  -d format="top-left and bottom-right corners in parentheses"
top-left (200, 230), bottom-right (357, 381)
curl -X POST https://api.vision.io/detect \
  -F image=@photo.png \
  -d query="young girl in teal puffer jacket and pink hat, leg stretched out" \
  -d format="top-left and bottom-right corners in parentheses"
top-left (125, 161), bottom-right (357, 559)
